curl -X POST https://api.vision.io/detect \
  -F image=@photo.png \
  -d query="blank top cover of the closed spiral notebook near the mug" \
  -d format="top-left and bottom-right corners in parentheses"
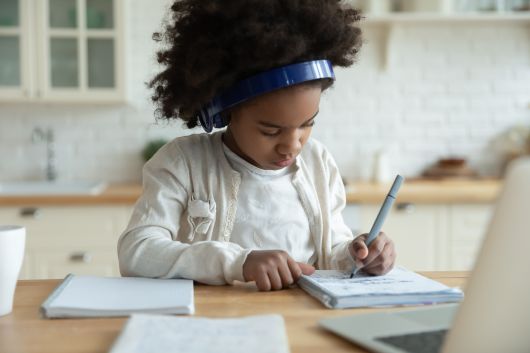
top-left (50, 276), bottom-right (193, 310)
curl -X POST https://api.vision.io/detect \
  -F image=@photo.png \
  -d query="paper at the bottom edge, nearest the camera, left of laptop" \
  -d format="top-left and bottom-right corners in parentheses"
top-left (110, 314), bottom-right (289, 353)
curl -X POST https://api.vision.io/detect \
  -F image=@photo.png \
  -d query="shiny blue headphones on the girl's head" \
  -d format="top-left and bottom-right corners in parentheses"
top-left (199, 60), bottom-right (335, 132)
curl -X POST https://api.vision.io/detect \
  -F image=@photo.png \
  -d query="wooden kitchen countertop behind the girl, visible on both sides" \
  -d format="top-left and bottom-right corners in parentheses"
top-left (0, 179), bottom-right (502, 206)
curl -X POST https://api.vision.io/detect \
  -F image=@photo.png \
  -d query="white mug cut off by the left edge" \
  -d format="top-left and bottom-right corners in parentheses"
top-left (0, 225), bottom-right (26, 316)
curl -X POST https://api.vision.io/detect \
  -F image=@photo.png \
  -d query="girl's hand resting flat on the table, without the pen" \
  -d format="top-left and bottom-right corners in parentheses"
top-left (243, 250), bottom-right (315, 291)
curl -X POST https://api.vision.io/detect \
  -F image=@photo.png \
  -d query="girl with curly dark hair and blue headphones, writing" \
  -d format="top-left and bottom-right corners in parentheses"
top-left (118, 0), bottom-right (396, 290)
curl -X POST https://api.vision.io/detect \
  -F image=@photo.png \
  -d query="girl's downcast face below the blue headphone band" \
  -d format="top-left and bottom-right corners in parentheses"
top-left (225, 85), bottom-right (321, 169)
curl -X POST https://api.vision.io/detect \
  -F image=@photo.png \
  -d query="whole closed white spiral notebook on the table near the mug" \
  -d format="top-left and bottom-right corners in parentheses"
top-left (41, 274), bottom-right (194, 318)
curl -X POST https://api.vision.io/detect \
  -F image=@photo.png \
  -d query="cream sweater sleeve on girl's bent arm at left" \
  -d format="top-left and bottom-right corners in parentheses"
top-left (118, 144), bottom-right (249, 284)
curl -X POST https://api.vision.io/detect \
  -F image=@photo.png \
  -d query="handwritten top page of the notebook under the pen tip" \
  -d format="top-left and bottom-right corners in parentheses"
top-left (309, 267), bottom-right (451, 296)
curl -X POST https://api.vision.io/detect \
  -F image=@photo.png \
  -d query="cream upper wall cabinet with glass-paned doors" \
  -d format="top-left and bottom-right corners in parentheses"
top-left (0, 0), bottom-right (125, 102)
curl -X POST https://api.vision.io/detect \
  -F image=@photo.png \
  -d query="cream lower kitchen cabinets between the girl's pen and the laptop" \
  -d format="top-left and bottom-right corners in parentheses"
top-left (347, 202), bottom-right (493, 271)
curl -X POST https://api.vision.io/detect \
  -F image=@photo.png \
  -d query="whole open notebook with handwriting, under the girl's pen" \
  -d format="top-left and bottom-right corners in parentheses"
top-left (298, 267), bottom-right (464, 309)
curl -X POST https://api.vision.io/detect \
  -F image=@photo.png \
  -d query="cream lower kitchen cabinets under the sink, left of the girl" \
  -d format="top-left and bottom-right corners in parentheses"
top-left (0, 205), bottom-right (132, 279)
